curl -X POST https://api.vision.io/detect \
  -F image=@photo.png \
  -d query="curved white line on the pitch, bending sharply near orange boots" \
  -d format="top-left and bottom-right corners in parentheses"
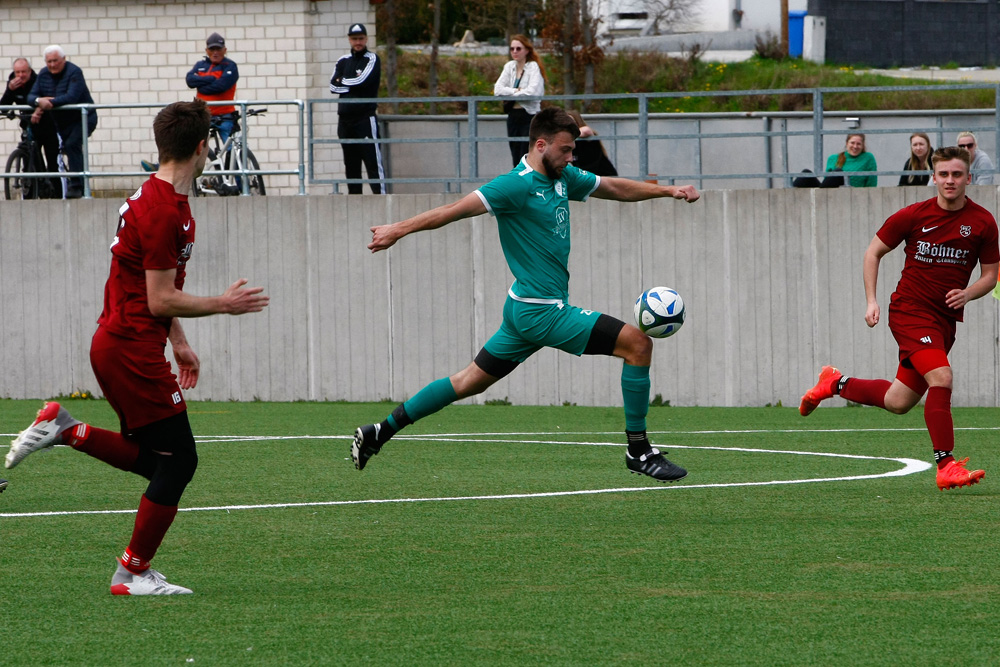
top-left (0, 429), bottom-right (931, 518)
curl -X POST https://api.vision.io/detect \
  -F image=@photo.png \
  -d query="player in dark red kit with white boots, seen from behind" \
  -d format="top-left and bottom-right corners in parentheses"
top-left (5, 100), bottom-right (268, 595)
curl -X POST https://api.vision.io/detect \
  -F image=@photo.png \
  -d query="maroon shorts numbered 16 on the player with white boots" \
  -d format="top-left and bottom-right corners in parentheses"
top-left (90, 326), bottom-right (187, 433)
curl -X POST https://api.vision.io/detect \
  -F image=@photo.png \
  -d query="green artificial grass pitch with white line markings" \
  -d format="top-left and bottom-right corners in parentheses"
top-left (0, 400), bottom-right (1000, 665)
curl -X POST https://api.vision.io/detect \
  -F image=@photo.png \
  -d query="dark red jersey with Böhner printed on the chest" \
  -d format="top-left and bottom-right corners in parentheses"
top-left (878, 197), bottom-right (1000, 322)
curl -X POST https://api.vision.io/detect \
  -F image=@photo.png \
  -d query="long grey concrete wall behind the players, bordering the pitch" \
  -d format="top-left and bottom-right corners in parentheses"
top-left (0, 186), bottom-right (1000, 406)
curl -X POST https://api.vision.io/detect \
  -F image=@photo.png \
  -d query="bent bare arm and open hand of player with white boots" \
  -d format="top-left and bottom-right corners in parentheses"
top-left (146, 269), bottom-right (270, 317)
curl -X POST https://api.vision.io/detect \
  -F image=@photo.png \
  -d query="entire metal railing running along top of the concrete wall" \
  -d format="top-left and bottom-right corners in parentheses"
top-left (0, 83), bottom-right (1000, 197)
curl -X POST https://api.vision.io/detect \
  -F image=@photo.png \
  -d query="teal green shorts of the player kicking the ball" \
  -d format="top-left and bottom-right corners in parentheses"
top-left (483, 295), bottom-right (604, 363)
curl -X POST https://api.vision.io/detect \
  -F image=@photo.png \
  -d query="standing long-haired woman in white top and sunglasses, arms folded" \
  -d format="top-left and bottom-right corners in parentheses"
top-left (493, 35), bottom-right (545, 167)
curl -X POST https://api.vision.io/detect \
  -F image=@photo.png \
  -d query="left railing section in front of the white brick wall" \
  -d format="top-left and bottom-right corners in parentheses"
top-left (0, 100), bottom-right (306, 198)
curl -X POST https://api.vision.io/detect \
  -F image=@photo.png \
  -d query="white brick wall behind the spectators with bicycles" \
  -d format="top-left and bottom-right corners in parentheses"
top-left (0, 0), bottom-right (377, 194)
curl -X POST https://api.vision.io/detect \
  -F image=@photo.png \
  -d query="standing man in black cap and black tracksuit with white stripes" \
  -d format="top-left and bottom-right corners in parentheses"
top-left (330, 23), bottom-right (385, 195)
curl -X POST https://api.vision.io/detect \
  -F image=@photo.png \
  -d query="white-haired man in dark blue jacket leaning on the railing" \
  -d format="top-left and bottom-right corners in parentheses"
top-left (28, 44), bottom-right (97, 199)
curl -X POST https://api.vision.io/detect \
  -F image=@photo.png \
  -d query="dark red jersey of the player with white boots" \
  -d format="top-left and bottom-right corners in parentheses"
top-left (97, 175), bottom-right (194, 343)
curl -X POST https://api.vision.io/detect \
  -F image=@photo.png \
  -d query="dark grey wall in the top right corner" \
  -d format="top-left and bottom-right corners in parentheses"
top-left (808, 0), bottom-right (1000, 67)
